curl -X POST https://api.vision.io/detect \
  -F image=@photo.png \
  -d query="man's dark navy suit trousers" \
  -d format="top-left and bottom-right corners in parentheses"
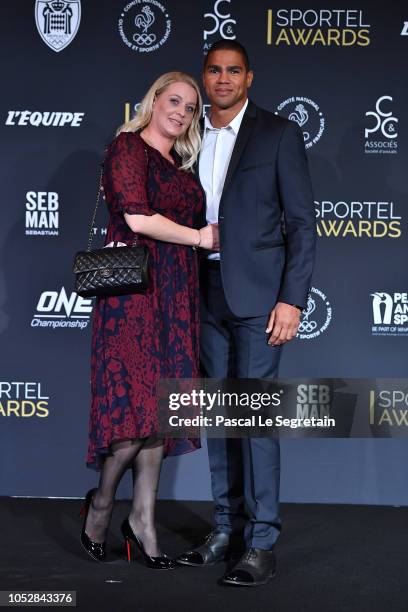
top-left (200, 261), bottom-right (281, 550)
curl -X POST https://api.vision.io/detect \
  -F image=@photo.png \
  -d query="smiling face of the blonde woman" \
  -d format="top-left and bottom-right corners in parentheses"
top-left (150, 82), bottom-right (198, 139)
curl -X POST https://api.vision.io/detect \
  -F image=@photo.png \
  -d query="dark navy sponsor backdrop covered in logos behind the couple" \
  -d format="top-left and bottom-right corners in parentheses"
top-left (0, 0), bottom-right (408, 504)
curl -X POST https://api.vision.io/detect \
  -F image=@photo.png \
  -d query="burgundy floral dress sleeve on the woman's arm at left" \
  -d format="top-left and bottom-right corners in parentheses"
top-left (104, 132), bottom-right (155, 215)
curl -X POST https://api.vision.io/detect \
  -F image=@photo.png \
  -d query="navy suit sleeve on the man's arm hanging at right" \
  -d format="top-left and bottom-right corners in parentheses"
top-left (278, 121), bottom-right (316, 307)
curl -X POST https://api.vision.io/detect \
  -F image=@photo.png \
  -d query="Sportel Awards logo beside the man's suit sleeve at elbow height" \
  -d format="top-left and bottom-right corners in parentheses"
top-left (315, 200), bottom-right (401, 238)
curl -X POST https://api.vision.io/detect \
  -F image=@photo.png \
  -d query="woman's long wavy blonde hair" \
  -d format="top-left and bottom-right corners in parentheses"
top-left (116, 72), bottom-right (203, 170)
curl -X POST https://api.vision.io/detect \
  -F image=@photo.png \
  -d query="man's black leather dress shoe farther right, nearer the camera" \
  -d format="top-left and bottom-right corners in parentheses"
top-left (222, 548), bottom-right (276, 586)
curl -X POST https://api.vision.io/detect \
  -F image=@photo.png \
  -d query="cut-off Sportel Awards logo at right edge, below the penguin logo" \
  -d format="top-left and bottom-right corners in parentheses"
top-left (369, 390), bottom-right (408, 427)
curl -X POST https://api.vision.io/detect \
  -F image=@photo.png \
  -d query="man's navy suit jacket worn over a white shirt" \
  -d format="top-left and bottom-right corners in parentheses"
top-left (199, 101), bottom-right (316, 317)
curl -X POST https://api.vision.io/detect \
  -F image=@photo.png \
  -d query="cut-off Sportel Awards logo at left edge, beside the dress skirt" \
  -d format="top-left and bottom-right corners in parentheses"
top-left (0, 381), bottom-right (50, 418)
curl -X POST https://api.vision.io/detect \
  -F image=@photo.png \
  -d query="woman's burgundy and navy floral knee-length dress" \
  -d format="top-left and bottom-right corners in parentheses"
top-left (87, 132), bottom-right (203, 469)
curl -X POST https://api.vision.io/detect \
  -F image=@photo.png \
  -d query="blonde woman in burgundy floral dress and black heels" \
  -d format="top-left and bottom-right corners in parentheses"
top-left (81, 72), bottom-right (218, 569)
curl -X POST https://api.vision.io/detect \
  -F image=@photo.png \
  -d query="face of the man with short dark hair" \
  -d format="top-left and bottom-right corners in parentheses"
top-left (203, 50), bottom-right (253, 109)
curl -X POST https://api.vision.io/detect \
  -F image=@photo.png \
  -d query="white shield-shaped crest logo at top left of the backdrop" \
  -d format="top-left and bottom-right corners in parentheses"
top-left (35, 0), bottom-right (81, 52)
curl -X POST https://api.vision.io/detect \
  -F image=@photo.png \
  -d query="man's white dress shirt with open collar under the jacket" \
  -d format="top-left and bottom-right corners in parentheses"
top-left (199, 100), bottom-right (248, 259)
